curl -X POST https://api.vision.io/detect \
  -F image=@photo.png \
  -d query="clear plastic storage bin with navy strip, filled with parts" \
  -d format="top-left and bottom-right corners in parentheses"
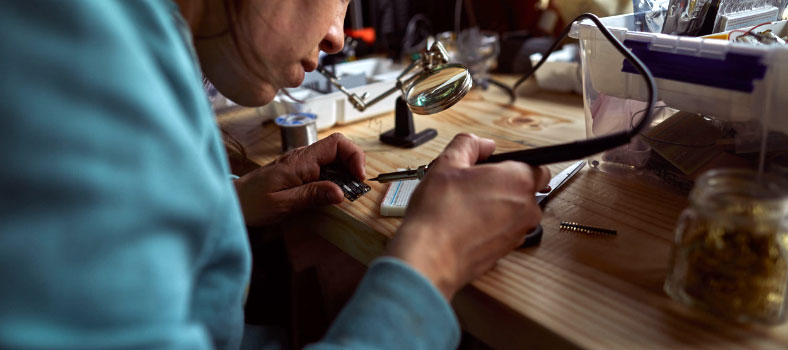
top-left (570, 14), bottom-right (788, 188)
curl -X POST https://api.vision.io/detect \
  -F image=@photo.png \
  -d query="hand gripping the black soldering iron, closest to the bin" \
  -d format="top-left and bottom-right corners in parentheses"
top-left (386, 134), bottom-right (550, 300)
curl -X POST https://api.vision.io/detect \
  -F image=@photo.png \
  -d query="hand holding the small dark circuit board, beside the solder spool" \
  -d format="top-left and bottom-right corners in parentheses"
top-left (234, 134), bottom-right (366, 226)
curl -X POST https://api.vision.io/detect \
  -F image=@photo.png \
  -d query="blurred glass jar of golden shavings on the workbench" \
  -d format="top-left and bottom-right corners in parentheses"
top-left (664, 169), bottom-right (788, 324)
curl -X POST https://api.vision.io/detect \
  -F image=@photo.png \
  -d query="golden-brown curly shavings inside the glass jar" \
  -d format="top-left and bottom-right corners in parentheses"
top-left (674, 224), bottom-right (788, 321)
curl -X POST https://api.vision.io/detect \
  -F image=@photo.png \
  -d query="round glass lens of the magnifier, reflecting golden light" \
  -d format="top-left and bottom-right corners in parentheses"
top-left (405, 64), bottom-right (473, 114)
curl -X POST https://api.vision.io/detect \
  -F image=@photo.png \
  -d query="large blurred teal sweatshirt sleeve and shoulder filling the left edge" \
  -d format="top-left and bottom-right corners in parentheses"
top-left (0, 0), bottom-right (249, 349)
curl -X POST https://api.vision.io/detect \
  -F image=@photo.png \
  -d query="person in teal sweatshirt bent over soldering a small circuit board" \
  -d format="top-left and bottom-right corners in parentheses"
top-left (0, 0), bottom-right (549, 349)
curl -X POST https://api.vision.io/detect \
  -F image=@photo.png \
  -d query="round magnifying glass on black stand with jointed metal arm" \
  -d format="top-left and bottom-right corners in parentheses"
top-left (317, 42), bottom-right (473, 148)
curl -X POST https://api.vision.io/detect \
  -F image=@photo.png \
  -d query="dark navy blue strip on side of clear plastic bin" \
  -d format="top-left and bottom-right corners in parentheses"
top-left (621, 40), bottom-right (767, 92)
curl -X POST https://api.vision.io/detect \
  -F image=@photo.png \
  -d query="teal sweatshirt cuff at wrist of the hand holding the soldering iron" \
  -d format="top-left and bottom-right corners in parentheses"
top-left (308, 257), bottom-right (460, 350)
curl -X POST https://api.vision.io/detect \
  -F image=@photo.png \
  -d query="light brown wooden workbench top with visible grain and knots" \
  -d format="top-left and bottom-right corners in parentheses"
top-left (221, 78), bottom-right (788, 349)
